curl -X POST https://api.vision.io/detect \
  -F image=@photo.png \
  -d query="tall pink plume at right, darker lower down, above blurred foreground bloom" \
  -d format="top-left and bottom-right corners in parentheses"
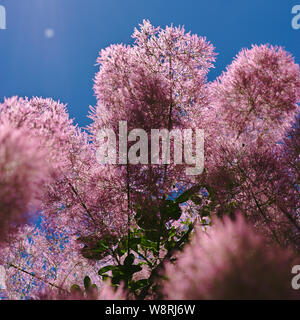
top-left (193, 45), bottom-right (300, 247)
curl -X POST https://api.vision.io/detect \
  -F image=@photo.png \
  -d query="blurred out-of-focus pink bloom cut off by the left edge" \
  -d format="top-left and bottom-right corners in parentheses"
top-left (0, 124), bottom-right (49, 241)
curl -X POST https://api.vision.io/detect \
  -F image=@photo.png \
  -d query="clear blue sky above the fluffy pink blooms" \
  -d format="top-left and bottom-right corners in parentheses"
top-left (0, 0), bottom-right (300, 126)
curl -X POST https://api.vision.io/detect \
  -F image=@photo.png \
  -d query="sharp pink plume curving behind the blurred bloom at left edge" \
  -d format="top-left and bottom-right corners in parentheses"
top-left (0, 97), bottom-right (113, 244)
